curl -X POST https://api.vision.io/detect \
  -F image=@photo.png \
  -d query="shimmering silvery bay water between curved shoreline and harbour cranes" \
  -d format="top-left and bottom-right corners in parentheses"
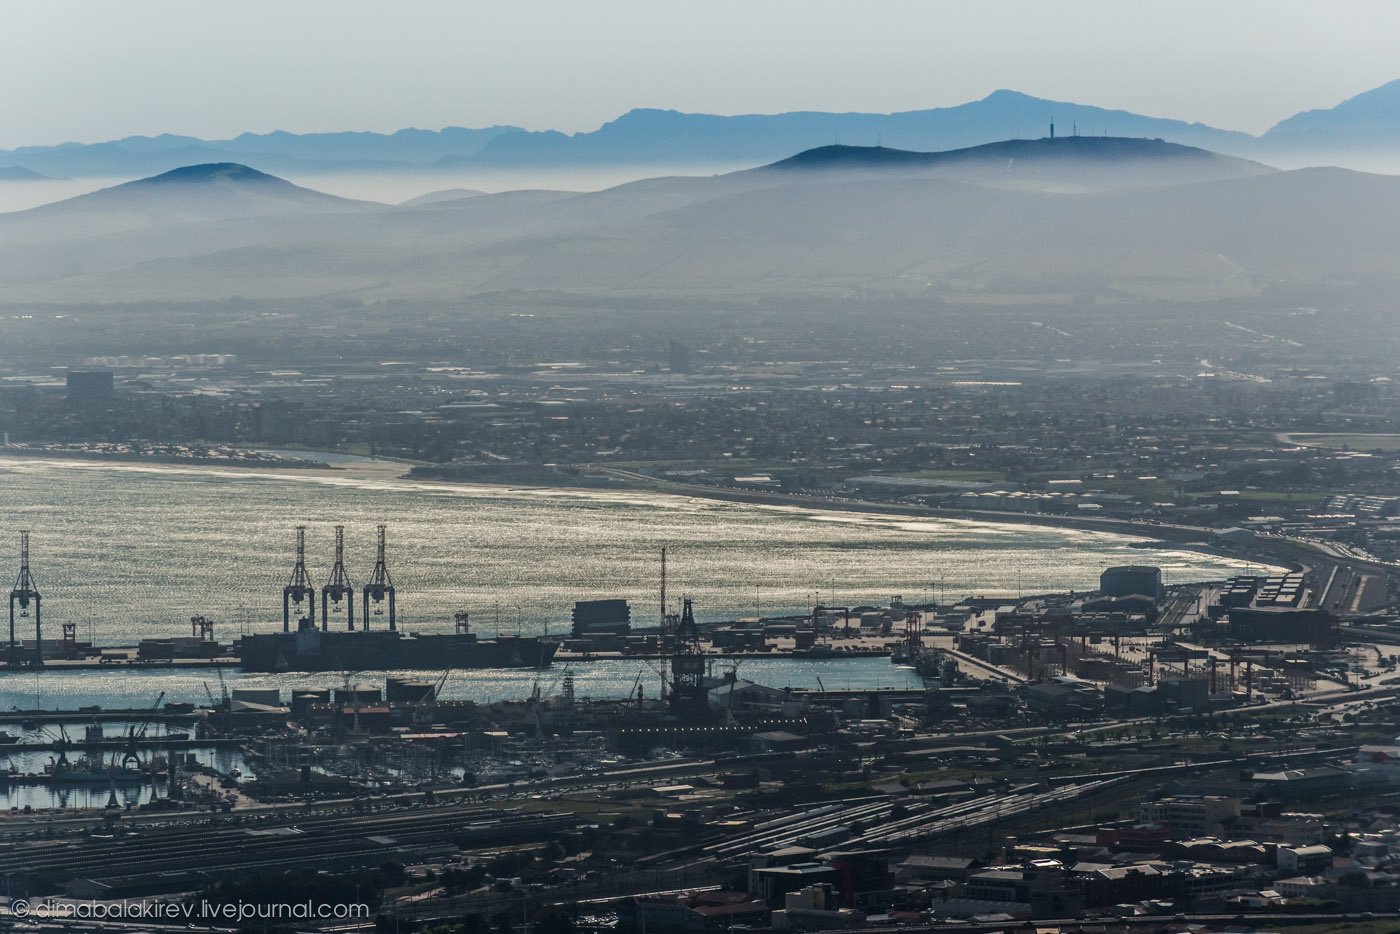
top-left (0, 458), bottom-right (1242, 644)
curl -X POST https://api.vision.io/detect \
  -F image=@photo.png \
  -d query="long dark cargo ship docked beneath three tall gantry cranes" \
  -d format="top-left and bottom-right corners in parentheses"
top-left (234, 620), bottom-right (559, 672)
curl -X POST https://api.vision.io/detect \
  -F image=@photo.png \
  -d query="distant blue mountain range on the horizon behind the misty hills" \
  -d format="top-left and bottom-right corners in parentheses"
top-left (0, 81), bottom-right (1400, 181)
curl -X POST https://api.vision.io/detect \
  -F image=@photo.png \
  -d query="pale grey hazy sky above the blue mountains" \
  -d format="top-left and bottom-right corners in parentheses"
top-left (0, 0), bottom-right (1400, 147)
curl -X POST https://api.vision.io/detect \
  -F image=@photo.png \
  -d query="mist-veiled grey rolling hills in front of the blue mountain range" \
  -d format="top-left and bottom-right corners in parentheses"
top-left (0, 137), bottom-right (1400, 307)
